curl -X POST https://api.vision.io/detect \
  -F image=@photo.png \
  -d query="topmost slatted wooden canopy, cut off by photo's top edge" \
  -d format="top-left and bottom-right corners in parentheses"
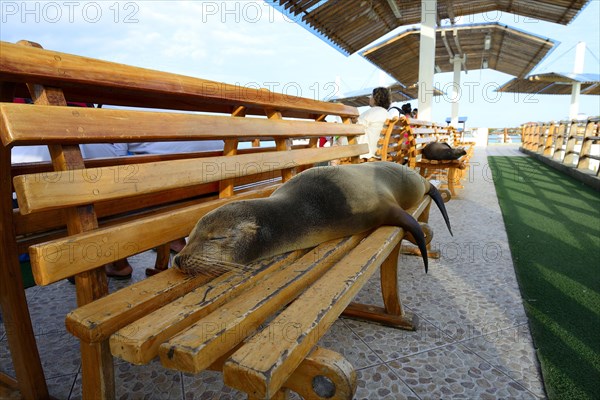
top-left (267, 0), bottom-right (589, 54)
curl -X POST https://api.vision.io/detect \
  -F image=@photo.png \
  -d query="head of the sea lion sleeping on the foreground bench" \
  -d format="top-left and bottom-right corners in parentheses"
top-left (173, 201), bottom-right (261, 274)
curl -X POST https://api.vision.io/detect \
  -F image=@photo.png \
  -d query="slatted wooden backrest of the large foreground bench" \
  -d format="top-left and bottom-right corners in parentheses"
top-left (0, 42), bottom-right (365, 290)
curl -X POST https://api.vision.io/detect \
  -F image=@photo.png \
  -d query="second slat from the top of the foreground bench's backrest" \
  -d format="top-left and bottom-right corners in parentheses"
top-left (0, 103), bottom-right (364, 146)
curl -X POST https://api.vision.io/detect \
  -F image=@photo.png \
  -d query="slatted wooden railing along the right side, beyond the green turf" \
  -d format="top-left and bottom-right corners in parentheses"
top-left (521, 117), bottom-right (600, 187)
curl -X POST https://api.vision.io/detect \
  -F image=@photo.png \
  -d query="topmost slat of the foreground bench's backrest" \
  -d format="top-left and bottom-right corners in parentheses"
top-left (0, 42), bottom-right (358, 117)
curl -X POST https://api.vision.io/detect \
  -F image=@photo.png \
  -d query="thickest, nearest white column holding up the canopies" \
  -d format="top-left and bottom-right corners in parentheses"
top-left (418, 0), bottom-right (437, 120)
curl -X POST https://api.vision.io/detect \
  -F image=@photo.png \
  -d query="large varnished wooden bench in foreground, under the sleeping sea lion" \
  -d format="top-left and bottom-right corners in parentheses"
top-left (0, 42), bottom-right (440, 399)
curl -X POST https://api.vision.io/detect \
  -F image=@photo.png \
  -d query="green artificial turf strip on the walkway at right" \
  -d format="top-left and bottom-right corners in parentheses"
top-left (488, 157), bottom-right (600, 400)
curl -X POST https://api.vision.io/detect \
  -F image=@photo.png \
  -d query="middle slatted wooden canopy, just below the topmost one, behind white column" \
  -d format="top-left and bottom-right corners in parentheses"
top-left (361, 23), bottom-right (556, 85)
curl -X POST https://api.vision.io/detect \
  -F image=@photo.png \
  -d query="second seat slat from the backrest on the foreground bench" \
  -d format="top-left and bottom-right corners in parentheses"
top-left (110, 251), bottom-right (305, 365)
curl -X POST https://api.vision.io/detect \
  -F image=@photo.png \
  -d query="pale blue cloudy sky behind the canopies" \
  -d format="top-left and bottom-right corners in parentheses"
top-left (0, 0), bottom-right (600, 128)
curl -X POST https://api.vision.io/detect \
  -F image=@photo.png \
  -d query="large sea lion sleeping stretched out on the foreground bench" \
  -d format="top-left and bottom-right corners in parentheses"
top-left (173, 162), bottom-right (452, 273)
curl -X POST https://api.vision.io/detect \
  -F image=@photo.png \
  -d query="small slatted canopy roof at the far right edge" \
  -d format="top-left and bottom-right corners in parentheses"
top-left (496, 72), bottom-right (600, 95)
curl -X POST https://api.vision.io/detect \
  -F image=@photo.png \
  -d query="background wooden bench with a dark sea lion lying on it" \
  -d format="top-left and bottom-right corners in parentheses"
top-left (377, 117), bottom-right (473, 196)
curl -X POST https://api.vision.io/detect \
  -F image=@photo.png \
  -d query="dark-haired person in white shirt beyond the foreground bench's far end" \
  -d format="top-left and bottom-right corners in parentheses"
top-left (358, 87), bottom-right (391, 161)
